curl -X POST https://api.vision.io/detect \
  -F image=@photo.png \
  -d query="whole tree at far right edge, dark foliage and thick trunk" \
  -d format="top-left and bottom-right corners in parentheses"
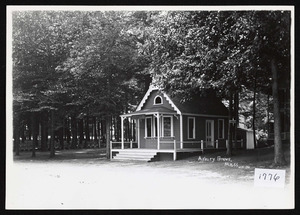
top-left (251, 11), bottom-right (291, 165)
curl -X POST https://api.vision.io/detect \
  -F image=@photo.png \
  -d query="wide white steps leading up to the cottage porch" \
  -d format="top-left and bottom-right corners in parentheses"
top-left (113, 150), bottom-right (157, 161)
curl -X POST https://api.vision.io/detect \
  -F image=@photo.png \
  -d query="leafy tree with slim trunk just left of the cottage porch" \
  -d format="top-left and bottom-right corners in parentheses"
top-left (56, 12), bottom-right (149, 156)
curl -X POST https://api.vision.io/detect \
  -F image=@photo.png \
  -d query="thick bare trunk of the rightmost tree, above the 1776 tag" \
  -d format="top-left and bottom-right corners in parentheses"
top-left (271, 59), bottom-right (286, 165)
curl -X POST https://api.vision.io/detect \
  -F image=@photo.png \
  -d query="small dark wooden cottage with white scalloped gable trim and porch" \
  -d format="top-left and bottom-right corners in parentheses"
top-left (111, 85), bottom-right (228, 160)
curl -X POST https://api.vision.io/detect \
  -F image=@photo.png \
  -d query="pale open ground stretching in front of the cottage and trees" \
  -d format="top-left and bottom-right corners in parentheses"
top-left (6, 146), bottom-right (293, 209)
